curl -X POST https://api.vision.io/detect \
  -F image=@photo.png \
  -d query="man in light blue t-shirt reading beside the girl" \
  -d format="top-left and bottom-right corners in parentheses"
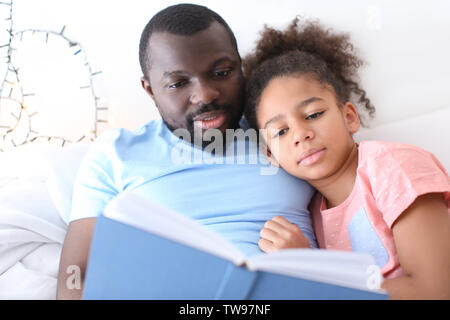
top-left (57, 4), bottom-right (315, 299)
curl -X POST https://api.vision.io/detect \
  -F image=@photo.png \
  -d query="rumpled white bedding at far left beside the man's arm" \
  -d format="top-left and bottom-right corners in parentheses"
top-left (0, 144), bottom-right (88, 299)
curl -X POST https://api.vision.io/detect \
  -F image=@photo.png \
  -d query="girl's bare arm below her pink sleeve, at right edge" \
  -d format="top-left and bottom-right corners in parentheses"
top-left (382, 193), bottom-right (450, 299)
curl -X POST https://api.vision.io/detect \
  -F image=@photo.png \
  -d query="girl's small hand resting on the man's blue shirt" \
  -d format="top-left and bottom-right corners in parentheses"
top-left (258, 216), bottom-right (311, 253)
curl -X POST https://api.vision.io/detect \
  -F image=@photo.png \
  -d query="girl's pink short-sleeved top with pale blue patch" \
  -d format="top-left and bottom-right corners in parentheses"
top-left (313, 141), bottom-right (450, 278)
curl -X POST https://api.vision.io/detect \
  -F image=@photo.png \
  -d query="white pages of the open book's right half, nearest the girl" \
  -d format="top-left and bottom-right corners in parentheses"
top-left (246, 249), bottom-right (382, 290)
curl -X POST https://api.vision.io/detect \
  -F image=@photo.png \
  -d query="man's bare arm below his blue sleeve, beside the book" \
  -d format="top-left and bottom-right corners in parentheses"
top-left (56, 218), bottom-right (96, 299)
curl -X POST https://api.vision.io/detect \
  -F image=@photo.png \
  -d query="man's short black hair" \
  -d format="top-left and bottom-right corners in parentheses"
top-left (139, 3), bottom-right (239, 80)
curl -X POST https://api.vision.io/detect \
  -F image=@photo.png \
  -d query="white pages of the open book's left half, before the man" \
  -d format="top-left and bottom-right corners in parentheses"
top-left (104, 192), bottom-right (245, 265)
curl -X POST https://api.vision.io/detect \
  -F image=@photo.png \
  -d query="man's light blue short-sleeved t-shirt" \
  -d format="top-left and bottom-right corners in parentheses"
top-left (70, 119), bottom-right (317, 256)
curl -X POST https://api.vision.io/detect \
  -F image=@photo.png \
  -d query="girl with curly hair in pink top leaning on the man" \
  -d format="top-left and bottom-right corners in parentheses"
top-left (244, 19), bottom-right (450, 299)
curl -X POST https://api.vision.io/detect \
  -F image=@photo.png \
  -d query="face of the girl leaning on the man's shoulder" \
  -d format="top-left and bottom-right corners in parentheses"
top-left (257, 75), bottom-right (360, 182)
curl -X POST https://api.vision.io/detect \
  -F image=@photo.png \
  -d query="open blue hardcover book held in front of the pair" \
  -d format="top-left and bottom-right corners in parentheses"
top-left (83, 192), bottom-right (388, 300)
